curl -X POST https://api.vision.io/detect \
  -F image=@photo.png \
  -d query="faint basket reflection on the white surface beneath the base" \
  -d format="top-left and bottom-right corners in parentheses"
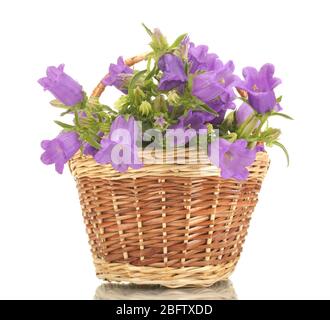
top-left (95, 280), bottom-right (237, 300)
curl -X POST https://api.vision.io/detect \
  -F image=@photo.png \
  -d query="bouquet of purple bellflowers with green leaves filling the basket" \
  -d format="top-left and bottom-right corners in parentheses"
top-left (39, 26), bottom-right (291, 180)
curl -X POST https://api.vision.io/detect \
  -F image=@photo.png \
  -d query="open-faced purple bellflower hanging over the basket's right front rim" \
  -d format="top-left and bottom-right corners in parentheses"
top-left (208, 138), bottom-right (256, 180)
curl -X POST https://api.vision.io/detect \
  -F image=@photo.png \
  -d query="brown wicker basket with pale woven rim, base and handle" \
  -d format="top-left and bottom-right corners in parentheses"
top-left (69, 56), bottom-right (269, 287)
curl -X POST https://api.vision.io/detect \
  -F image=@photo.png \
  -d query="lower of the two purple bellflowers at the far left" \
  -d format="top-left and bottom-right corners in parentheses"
top-left (41, 132), bottom-right (81, 173)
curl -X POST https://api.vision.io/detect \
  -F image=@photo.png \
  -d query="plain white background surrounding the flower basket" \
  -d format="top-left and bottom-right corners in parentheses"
top-left (0, 0), bottom-right (330, 299)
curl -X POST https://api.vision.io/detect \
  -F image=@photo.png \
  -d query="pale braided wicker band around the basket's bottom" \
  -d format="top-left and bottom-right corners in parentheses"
top-left (94, 258), bottom-right (238, 288)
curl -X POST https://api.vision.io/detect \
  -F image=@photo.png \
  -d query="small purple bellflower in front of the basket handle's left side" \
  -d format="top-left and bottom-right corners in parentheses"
top-left (103, 57), bottom-right (133, 94)
